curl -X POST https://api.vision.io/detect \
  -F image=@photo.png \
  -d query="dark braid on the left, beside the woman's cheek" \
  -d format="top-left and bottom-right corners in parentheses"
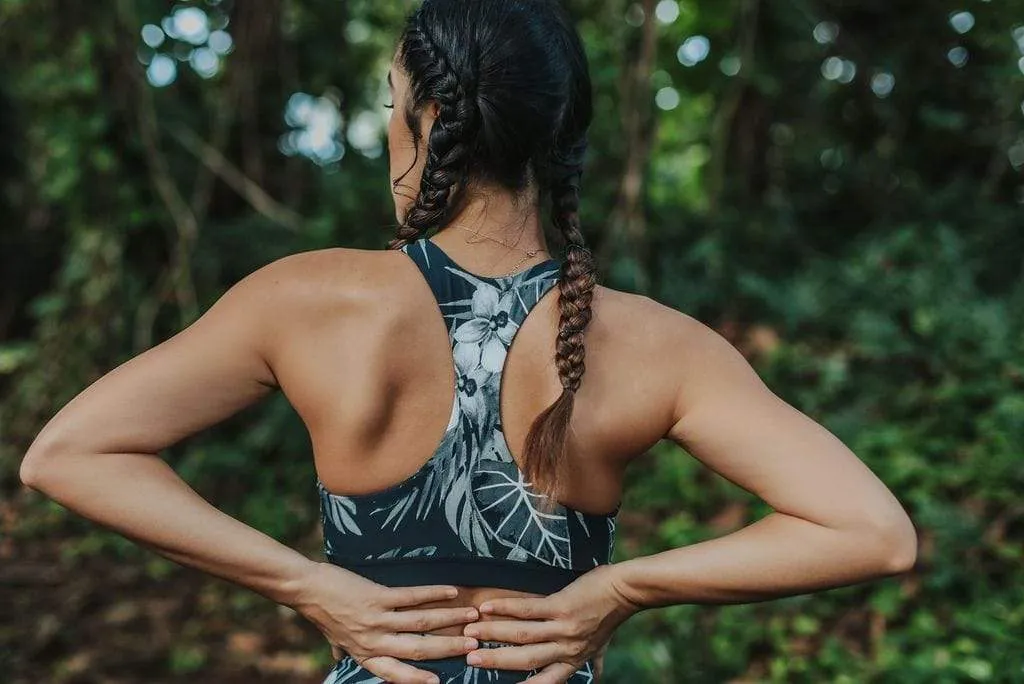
top-left (388, 12), bottom-right (479, 249)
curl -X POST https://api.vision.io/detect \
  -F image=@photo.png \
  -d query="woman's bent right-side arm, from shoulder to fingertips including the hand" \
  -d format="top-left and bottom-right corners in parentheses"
top-left (467, 314), bottom-right (916, 684)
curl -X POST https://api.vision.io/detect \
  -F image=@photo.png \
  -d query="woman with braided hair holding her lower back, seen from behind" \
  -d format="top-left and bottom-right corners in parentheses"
top-left (20, 0), bottom-right (915, 684)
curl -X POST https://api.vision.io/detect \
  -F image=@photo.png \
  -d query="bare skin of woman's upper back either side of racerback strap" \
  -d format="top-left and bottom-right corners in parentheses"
top-left (280, 249), bottom-right (675, 520)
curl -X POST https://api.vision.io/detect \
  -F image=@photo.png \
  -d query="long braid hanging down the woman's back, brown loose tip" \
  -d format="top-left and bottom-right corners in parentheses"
top-left (523, 137), bottom-right (597, 508)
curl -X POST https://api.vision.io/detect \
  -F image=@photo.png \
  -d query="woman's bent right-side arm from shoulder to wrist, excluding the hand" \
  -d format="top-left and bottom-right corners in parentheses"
top-left (615, 316), bottom-right (918, 607)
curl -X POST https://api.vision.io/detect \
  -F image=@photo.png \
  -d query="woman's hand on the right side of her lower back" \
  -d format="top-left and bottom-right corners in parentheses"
top-left (463, 565), bottom-right (641, 684)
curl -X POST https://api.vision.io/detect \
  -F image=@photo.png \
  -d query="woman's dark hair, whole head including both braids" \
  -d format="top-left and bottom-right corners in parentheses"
top-left (388, 0), bottom-right (596, 505)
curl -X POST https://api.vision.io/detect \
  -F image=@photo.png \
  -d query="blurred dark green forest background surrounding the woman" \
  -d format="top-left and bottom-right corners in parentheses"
top-left (0, 0), bottom-right (1024, 684)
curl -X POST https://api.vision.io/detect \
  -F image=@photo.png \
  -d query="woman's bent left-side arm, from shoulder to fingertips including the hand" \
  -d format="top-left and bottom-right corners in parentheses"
top-left (20, 253), bottom-right (479, 682)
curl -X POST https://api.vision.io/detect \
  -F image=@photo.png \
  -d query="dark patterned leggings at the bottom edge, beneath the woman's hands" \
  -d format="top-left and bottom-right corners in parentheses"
top-left (323, 641), bottom-right (596, 684)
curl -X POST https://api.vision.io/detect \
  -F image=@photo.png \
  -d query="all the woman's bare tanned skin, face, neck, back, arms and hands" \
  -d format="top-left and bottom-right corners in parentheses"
top-left (20, 53), bottom-right (916, 684)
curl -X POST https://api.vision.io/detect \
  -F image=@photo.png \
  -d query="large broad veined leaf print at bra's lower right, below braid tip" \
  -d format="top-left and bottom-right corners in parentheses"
top-left (473, 459), bottom-right (571, 567)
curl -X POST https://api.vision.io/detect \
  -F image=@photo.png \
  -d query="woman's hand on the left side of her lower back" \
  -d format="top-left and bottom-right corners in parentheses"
top-left (292, 561), bottom-right (479, 684)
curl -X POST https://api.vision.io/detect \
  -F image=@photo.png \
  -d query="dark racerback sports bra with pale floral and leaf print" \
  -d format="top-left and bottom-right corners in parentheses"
top-left (316, 239), bottom-right (618, 594)
